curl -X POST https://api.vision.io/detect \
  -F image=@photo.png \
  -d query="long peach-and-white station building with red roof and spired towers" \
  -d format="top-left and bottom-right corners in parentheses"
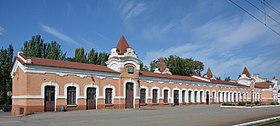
top-left (11, 36), bottom-right (277, 116)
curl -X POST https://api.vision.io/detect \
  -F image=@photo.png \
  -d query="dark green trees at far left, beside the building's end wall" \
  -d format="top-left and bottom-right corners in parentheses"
top-left (0, 45), bottom-right (14, 104)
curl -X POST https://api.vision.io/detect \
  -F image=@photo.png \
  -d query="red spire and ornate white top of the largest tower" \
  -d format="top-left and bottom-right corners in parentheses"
top-left (106, 35), bottom-right (141, 72)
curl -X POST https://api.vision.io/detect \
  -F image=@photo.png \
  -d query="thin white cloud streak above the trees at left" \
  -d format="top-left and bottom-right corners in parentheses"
top-left (41, 24), bottom-right (79, 45)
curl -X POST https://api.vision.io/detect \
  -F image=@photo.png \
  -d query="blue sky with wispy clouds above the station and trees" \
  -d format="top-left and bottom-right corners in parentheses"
top-left (0, 0), bottom-right (280, 79)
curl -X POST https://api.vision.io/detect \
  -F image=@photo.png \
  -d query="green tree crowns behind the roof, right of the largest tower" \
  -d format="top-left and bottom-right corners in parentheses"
top-left (150, 55), bottom-right (204, 76)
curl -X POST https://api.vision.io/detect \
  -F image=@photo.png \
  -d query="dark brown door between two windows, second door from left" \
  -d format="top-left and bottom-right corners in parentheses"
top-left (87, 88), bottom-right (96, 109)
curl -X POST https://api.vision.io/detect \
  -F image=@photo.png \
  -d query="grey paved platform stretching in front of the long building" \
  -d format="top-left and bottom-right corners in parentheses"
top-left (0, 105), bottom-right (280, 126)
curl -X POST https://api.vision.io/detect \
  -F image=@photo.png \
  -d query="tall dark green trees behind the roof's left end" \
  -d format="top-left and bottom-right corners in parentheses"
top-left (22, 35), bottom-right (66, 60)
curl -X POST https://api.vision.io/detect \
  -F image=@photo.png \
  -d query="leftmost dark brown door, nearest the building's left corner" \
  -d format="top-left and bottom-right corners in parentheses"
top-left (45, 86), bottom-right (55, 111)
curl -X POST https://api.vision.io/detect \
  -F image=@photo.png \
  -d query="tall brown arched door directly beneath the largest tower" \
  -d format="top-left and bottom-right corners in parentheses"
top-left (125, 83), bottom-right (133, 108)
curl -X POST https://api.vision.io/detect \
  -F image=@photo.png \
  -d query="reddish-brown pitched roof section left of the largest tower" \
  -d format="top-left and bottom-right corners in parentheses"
top-left (16, 53), bottom-right (118, 73)
